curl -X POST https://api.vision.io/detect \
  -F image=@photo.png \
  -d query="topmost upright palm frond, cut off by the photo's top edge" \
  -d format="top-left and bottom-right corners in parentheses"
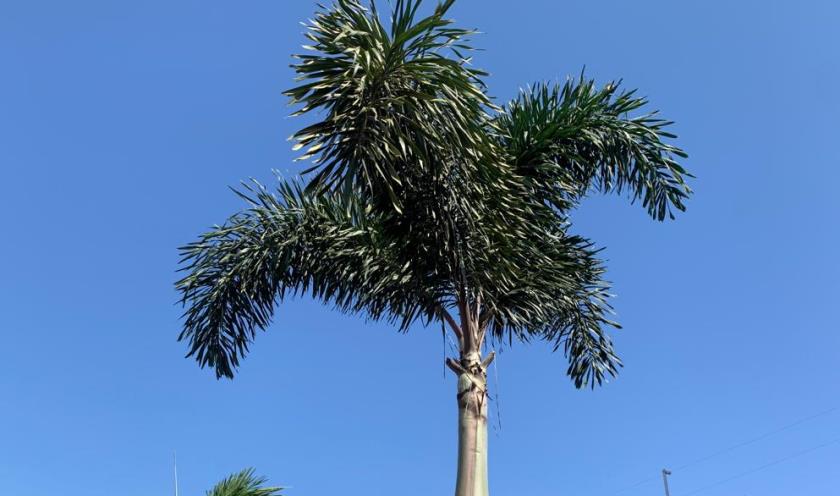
top-left (286, 0), bottom-right (492, 209)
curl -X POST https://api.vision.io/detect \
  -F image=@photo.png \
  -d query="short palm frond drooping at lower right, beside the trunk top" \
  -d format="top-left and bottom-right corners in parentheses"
top-left (482, 217), bottom-right (621, 388)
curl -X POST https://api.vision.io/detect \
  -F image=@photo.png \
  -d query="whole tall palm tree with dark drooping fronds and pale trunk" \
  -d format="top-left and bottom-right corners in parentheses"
top-left (177, 0), bottom-right (691, 496)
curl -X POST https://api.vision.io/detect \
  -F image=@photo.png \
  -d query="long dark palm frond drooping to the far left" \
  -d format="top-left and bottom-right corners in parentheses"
top-left (177, 180), bottom-right (443, 377)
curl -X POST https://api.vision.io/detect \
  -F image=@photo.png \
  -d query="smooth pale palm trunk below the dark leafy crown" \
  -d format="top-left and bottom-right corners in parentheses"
top-left (455, 372), bottom-right (490, 496)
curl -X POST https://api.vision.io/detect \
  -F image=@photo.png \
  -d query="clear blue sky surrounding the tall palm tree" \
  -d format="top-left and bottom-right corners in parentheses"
top-left (0, 0), bottom-right (840, 496)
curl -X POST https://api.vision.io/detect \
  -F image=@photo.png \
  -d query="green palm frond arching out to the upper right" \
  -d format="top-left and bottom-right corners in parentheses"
top-left (495, 76), bottom-right (692, 220)
